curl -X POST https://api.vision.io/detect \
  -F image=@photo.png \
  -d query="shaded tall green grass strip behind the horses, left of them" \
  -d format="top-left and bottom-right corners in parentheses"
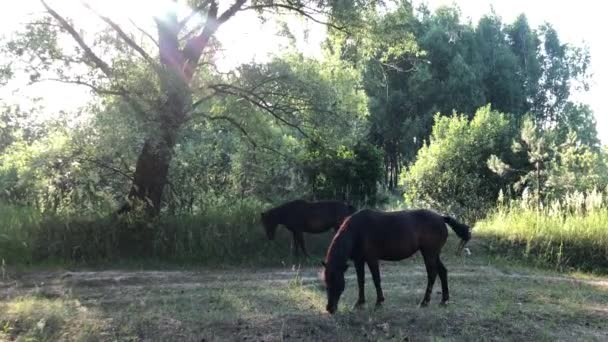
top-left (0, 200), bottom-right (332, 265)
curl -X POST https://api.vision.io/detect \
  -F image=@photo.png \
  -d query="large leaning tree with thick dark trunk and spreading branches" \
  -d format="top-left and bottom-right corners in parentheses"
top-left (8, 0), bottom-right (368, 215)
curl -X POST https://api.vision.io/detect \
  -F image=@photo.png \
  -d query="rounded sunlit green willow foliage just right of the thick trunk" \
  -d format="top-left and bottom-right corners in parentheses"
top-left (167, 55), bottom-right (367, 213)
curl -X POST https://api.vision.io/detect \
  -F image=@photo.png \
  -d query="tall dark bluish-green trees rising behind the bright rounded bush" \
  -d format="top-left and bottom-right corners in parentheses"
top-left (338, 2), bottom-right (597, 188)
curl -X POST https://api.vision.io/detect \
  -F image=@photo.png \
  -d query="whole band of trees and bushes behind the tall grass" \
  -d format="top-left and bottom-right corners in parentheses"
top-left (0, 0), bottom-right (606, 216)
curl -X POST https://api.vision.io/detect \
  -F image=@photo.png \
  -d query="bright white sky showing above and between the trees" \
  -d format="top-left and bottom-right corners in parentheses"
top-left (0, 0), bottom-right (608, 144)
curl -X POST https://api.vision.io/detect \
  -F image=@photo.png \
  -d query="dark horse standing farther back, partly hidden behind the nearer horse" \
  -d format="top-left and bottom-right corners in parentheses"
top-left (261, 200), bottom-right (357, 256)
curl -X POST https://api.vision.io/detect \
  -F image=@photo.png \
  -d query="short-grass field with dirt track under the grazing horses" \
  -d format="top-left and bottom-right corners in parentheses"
top-left (0, 236), bottom-right (608, 341)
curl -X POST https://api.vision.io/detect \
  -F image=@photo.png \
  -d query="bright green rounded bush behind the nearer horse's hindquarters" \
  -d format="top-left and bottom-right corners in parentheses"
top-left (401, 106), bottom-right (510, 218)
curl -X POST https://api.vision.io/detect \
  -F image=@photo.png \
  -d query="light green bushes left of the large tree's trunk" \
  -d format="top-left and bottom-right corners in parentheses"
top-left (0, 105), bottom-right (137, 214)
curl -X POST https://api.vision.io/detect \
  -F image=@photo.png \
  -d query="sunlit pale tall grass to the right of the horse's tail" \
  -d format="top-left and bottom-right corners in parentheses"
top-left (474, 191), bottom-right (608, 272)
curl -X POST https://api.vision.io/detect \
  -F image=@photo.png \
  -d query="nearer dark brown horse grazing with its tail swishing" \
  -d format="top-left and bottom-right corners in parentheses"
top-left (323, 209), bottom-right (471, 314)
